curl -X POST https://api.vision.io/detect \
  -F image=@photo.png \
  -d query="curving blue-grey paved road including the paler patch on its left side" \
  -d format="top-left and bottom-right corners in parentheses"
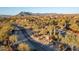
top-left (14, 25), bottom-right (55, 51)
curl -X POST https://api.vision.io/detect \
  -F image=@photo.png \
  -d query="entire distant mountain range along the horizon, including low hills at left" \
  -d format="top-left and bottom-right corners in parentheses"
top-left (0, 11), bottom-right (79, 17)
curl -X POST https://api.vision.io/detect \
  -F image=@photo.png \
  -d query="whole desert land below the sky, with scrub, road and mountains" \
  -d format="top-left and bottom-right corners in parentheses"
top-left (0, 7), bottom-right (79, 51)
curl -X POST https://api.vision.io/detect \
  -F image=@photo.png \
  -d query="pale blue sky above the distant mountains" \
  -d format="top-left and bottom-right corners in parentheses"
top-left (0, 7), bottom-right (79, 15)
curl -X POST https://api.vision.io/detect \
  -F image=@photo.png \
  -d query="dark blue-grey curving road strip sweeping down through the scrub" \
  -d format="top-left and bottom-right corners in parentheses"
top-left (13, 24), bottom-right (55, 51)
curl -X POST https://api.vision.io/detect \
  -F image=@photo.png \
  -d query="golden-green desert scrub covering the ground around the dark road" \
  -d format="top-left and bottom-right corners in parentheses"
top-left (0, 15), bottom-right (79, 51)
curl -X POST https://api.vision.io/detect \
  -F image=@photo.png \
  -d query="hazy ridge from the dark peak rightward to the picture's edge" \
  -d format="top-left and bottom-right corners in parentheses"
top-left (16, 11), bottom-right (79, 16)
